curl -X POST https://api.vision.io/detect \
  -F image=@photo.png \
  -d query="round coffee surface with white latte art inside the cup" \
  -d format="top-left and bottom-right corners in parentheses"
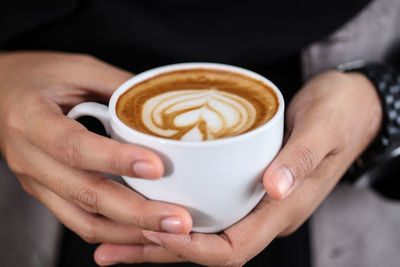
top-left (116, 69), bottom-right (279, 141)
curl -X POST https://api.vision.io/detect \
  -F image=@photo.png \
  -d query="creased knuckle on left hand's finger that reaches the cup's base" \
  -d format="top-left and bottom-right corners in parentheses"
top-left (71, 181), bottom-right (101, 213)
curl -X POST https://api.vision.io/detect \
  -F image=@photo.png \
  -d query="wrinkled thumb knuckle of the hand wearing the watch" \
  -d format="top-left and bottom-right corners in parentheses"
top-left (293, 145), bottom-right (316, 180)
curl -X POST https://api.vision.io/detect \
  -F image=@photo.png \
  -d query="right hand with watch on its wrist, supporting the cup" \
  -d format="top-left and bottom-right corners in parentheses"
top-left (95, 71), bottom-right (382, 266)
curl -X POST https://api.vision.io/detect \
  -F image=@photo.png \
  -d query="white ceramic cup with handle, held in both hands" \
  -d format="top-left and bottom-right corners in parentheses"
top-left (68, 63), bottom-right (284, 233)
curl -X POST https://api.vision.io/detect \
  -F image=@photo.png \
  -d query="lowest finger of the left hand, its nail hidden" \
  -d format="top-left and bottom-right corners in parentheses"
top-left (23, 178), bottom-right (155, 244)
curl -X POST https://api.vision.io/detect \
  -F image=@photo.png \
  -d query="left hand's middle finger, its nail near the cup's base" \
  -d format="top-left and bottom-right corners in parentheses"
top-left (22, 144), bottom-right (192, 233)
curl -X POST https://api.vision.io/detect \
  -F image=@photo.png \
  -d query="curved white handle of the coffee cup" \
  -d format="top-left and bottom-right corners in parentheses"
top-left (67, 102), bottom-right (111, 135)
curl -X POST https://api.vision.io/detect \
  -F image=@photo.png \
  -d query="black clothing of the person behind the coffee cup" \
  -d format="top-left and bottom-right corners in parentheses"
top-left (0, 0), bottom-right (376, 267)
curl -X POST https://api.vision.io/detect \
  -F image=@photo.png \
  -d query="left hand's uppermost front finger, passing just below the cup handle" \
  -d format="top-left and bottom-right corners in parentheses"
top-left (28, 104), bottom-right (164, 179)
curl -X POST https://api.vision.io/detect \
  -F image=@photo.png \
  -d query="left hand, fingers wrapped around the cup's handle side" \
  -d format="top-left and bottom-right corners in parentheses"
top-left (0, 52), bottom-right (191, 247)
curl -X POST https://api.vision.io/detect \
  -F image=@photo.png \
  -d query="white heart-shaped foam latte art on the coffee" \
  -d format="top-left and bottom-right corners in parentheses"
top-left (142, 89), bottom-right (256, 141)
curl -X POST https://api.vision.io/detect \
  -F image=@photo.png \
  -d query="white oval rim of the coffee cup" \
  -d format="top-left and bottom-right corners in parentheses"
top-left (108, 62), bottom-right (285, 146)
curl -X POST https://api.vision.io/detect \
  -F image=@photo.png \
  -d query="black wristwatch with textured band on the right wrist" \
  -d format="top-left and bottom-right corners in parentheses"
top-left (338, 62), bottom-right (400, 199)
